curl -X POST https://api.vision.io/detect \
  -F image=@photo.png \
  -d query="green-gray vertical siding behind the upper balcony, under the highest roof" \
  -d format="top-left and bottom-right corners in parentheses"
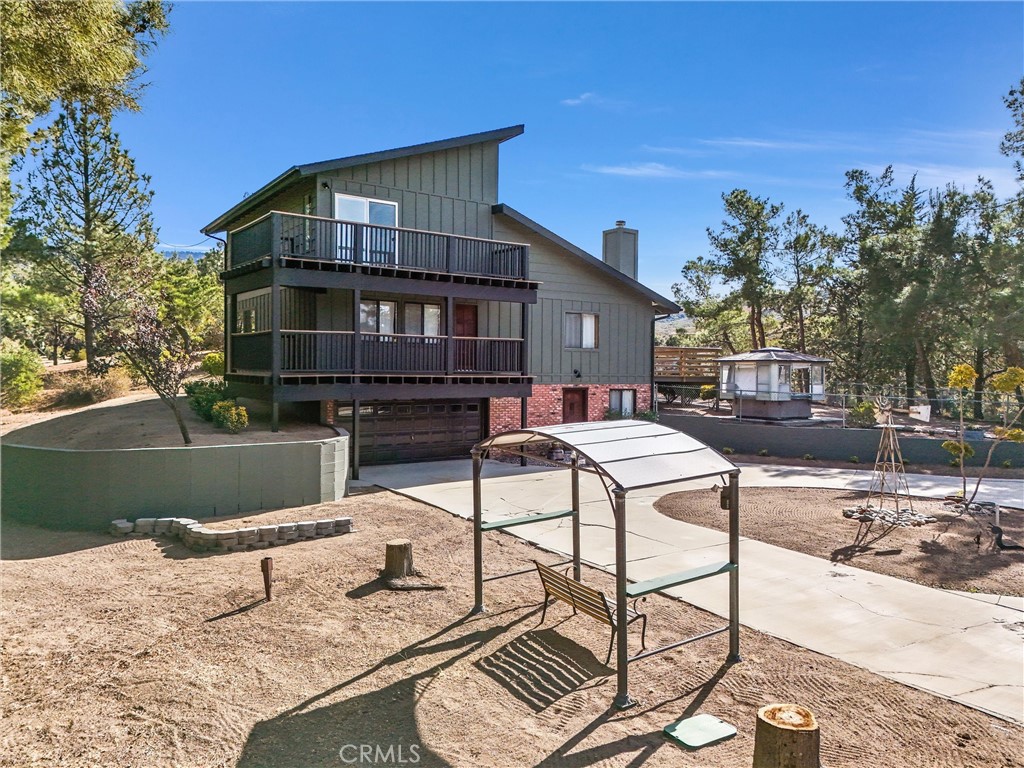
top-left (315, 142), bottom-right (498, 239)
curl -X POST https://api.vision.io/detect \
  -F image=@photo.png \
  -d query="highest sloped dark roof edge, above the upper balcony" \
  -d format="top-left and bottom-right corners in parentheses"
top-left (201, 125), bottom-right (525, 234)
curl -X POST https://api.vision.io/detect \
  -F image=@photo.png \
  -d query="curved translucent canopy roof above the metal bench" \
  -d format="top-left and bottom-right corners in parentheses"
top-left (473, 420), bottom-right (739, 490)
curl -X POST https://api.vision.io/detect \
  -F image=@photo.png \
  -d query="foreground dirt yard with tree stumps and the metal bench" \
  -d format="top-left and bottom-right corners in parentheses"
top-left (0, 492), bottom-right (1024, 768)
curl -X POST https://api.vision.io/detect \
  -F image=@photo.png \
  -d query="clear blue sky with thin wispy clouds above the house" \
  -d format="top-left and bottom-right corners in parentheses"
top-left (117, 1), bottom-right (1024, 295)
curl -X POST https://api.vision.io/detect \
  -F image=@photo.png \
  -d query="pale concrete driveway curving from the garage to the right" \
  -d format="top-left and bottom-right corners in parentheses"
top-left (362, 460), bottom-right (1024, 723)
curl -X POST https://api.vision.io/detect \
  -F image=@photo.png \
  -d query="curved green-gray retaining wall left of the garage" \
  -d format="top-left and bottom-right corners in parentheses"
top-left (0, 434), bottom-right (348, 530)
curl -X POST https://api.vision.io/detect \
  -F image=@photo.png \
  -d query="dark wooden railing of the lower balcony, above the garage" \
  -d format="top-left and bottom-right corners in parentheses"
top-left (230, 331), bottom-right (522, 375)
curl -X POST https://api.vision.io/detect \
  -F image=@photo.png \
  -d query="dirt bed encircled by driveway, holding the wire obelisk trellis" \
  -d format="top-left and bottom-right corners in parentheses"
top-left (654, 487), bottom-right (1024, 596)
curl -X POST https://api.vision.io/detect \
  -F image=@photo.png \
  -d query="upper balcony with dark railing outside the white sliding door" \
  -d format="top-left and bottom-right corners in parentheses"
top-left (227, 211), bottom-right (536, 288)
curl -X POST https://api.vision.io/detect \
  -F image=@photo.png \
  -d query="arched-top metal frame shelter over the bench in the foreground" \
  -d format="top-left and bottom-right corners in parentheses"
top-left (472, 420), bottom-right (739, 709)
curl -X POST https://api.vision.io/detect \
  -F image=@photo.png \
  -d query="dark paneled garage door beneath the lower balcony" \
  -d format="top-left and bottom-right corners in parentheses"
top-left (336, 399), bottom-right (484, 464)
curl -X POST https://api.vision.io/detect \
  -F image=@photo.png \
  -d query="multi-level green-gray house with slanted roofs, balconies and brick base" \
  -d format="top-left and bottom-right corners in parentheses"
top-left (203, 125), bottom-right (678, 477)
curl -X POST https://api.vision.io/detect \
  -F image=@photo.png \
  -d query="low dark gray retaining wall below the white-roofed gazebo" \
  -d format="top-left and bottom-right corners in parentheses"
top-left (660, 412), bottom-right (1024, 467)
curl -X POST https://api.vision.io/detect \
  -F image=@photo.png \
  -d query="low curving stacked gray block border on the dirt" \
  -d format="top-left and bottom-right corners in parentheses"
top-left (110, 517), bottom-right (352, 552)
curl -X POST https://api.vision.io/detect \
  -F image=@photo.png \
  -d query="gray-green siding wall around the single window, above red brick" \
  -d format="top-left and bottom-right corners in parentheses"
top-left (494, 216), bottom-right (653, 384)
